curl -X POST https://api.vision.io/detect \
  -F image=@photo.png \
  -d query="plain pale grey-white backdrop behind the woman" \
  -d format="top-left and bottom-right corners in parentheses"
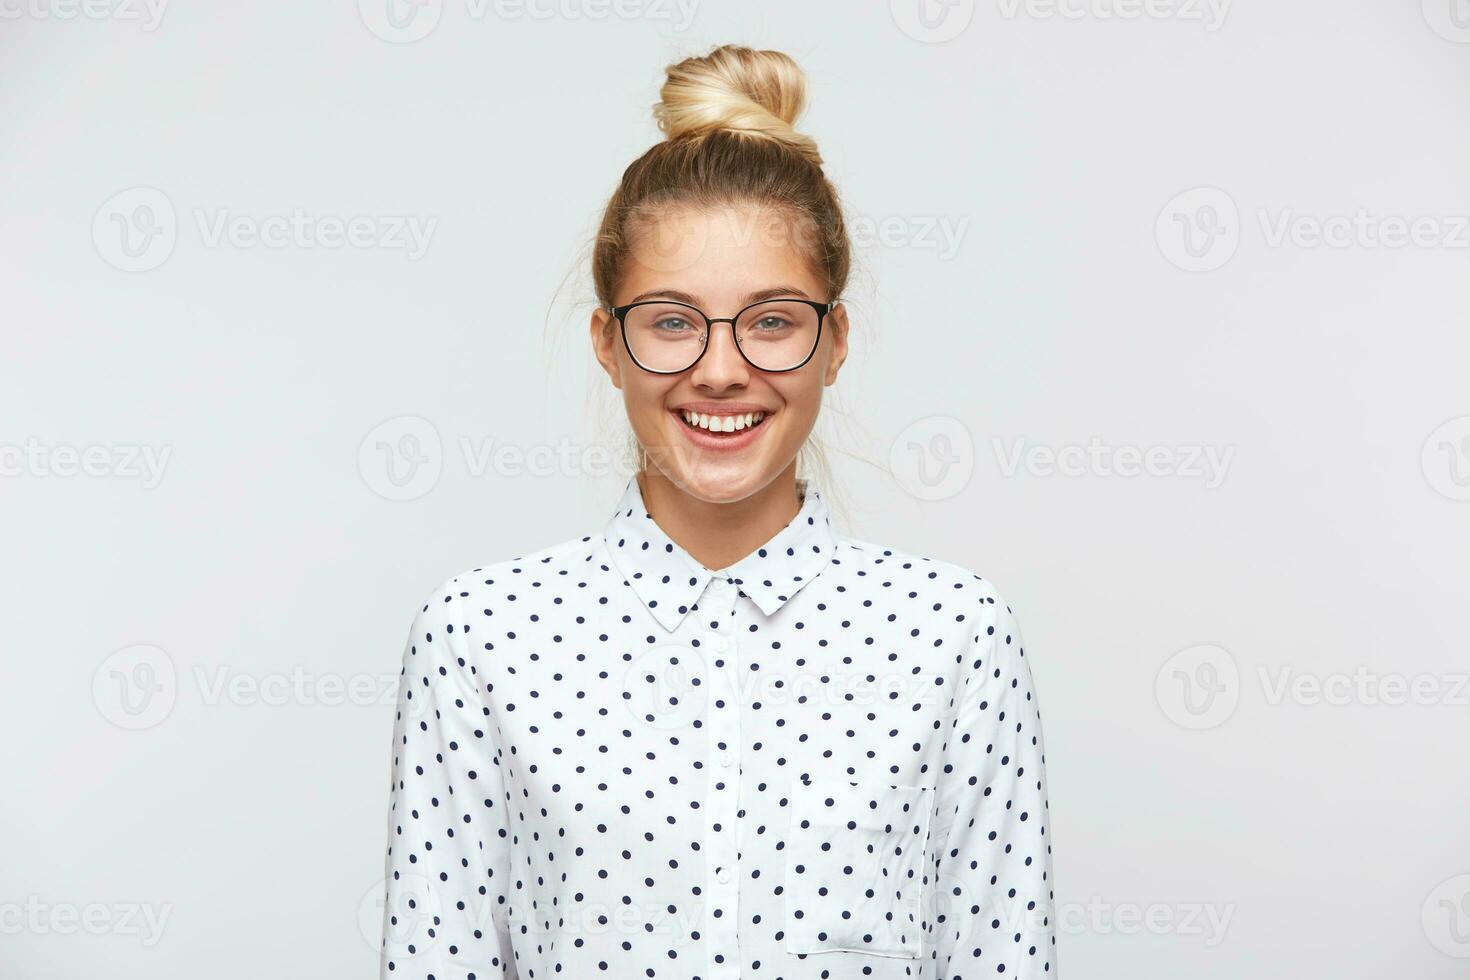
top-left (0, 0), bottom-right (1470, 980)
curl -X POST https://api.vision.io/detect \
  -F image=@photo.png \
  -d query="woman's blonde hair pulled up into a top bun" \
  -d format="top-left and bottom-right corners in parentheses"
top-left (592, 44), bottom-right (853, 505)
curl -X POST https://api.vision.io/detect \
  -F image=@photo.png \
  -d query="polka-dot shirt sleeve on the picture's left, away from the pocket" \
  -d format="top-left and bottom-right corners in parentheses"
top-left (379, 582), bottom-right (516, 980)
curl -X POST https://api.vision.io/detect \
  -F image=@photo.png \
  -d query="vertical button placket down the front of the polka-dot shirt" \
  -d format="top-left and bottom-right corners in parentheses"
top-left (700, 579), bottom-right (741, 980)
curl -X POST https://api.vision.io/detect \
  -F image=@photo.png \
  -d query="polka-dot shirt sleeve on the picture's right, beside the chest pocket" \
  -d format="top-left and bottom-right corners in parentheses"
top-left (933, 594), bottom-right (1057, 980)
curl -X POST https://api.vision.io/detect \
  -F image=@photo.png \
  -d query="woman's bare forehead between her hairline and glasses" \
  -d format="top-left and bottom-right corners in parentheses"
top-left (617, 207), bottom-right (823, 303)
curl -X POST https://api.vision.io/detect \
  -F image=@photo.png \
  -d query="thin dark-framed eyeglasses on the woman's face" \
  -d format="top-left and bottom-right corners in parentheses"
top-left (606, 298), bottom-right (838, 375)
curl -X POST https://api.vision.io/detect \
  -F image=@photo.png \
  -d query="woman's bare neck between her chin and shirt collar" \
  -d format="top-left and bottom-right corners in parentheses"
top-left (638, 463), bottom-right (801, 572)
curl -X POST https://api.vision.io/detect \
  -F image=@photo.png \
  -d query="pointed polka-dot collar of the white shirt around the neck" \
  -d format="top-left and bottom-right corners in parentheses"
top-left (603, 473), bottom-right (836, 633)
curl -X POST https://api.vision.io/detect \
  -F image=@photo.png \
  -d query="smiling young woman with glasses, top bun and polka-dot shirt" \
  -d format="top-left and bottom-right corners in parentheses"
top-left (373, 46), bottom-right (1057, 980)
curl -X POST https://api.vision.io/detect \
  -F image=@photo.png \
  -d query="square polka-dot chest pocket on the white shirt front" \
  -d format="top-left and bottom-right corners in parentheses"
top-left (786, 776), bottom-right (932, 958)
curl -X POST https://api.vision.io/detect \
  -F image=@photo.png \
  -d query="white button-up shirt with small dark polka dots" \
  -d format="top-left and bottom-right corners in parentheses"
top-left (381, 478), bottom-right (1057, 980)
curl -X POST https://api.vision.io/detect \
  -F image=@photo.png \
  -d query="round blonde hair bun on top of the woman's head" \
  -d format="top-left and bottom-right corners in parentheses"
top-left (653, 44), bottom-right (822, 166)
